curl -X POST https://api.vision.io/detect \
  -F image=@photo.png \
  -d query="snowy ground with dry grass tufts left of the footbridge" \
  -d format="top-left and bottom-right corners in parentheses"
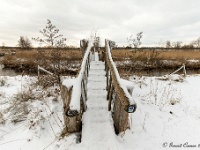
top-left (0, 76), bottom-right (77, 150)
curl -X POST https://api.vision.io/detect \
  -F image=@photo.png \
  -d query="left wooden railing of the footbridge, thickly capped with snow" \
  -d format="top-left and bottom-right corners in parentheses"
top-left (61, 40), bottom-right (91, 133)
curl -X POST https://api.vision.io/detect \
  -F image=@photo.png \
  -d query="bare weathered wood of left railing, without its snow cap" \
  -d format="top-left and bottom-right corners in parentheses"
top-left (61, 40), bottom-right (90, 133)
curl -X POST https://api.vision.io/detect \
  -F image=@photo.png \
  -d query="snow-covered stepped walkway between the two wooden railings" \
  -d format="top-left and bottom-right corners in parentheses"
top-left (71, 61), bottom-right (119, 150)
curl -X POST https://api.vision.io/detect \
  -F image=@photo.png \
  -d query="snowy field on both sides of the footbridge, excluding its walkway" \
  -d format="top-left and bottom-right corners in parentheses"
top-left (0, 75), bottom-right (200, 150)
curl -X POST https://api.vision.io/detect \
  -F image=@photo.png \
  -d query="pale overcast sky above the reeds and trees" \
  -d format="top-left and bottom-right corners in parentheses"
top-left (0, 0), bottom-right (200, 46)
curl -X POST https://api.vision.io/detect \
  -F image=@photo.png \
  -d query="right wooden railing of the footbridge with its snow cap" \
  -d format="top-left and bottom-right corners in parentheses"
top-left (105, 40), bottom-right (137, 134)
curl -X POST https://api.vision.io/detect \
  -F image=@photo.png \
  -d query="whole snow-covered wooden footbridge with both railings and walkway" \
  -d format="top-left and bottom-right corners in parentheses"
top-left (61, 40), bottom-right (136, 150)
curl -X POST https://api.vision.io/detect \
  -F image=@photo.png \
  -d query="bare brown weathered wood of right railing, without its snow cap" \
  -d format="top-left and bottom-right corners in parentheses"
top-left (105, 41), bottom-right (132, 134)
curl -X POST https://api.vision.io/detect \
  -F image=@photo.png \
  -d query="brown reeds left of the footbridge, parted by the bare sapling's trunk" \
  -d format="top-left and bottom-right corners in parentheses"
top-left (1, 49), bottom-right (82, 74)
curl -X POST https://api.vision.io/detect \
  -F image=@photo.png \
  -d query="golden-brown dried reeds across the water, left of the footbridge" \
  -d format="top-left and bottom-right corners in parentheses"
top-left (2, 49), bottom-right (82, 74)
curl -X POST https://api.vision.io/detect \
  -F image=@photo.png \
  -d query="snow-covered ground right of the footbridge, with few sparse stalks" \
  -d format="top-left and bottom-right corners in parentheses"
top-left (119, 75), bottom-right (200, 150)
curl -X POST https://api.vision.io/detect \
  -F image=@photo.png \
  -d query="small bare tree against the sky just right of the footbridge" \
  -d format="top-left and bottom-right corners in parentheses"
top-left (127, 32), bottom-right (143, 48)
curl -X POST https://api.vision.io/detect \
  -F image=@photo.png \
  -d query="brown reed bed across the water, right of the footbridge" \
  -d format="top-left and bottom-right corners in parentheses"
top-left (112, 48), bottom-right (200, 75)
